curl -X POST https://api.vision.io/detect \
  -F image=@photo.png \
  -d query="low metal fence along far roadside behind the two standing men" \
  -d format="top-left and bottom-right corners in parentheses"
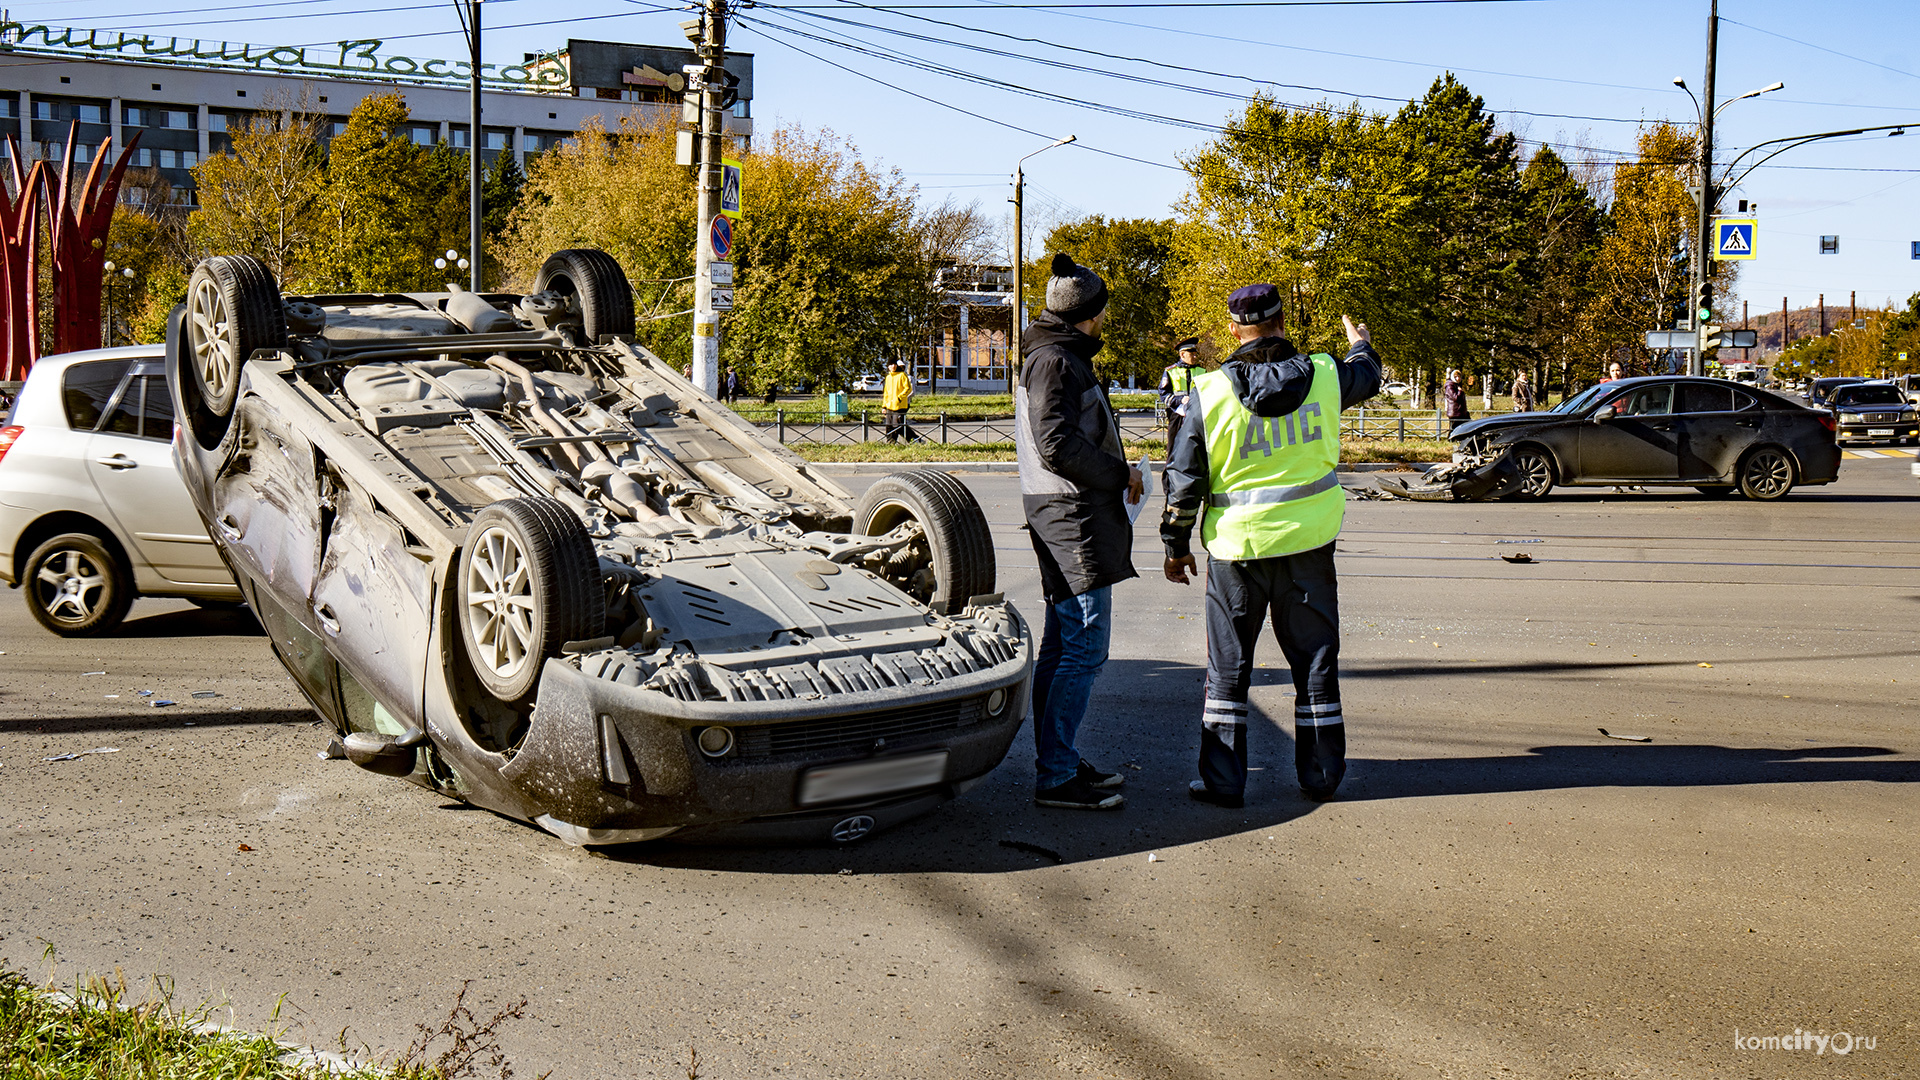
top-left (755, 407), bottom-right (1448, 446)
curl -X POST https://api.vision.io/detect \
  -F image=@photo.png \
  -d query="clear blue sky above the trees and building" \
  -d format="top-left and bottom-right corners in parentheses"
top-left (30, 0), bottom-right (1920, 311)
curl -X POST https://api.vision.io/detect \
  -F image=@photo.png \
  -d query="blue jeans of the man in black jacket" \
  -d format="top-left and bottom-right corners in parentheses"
top-left (1033, 586), bottom-right (1114, 790)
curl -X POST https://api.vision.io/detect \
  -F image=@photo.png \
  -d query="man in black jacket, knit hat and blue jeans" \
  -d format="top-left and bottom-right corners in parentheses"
top-left (1014, 256), bottom-right (1140, 809)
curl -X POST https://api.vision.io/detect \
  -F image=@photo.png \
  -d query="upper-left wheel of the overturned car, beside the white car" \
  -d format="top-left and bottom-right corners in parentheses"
top-left (184, 256), bottom-right (286, 419)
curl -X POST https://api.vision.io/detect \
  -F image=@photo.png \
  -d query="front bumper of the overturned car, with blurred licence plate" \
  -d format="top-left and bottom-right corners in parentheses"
top-left (499, 651), bottom-right (1033, 844)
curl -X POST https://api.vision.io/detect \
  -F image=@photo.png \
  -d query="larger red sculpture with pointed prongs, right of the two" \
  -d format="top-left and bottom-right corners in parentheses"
top-left (46, 123), bottom-right (140, 352)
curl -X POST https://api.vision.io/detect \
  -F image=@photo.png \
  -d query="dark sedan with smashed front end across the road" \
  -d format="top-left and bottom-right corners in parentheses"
top-left (1453, 375), bottom-right (1839, 500)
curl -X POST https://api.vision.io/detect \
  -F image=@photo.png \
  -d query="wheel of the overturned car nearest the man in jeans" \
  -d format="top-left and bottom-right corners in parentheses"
top-left (852, 469), bottom-right (996, 615)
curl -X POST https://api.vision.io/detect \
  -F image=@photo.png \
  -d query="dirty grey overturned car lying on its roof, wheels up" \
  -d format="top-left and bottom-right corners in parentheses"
top-left (167, 250), bottom-right (1033, 844)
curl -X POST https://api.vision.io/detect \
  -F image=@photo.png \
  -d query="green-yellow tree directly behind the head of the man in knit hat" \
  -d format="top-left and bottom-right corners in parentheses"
top-left (1021, 213), bottom-right (1187, 386)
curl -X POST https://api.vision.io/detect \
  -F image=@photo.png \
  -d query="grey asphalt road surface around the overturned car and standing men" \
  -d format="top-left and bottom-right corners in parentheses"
top-left (0, 459), bottom-right (1920, 1080)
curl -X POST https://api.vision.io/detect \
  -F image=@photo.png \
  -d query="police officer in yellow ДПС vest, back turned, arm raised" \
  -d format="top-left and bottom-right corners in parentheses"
top-left (1160, 284), bottom-right (1380, 807)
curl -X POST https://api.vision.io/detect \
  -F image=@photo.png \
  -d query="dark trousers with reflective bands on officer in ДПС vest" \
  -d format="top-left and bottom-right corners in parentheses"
top-left (1200, 544), bottom-right (1346, 796)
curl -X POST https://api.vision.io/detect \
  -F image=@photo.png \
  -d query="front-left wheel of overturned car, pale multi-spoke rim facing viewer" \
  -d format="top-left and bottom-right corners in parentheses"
top-left (457, 498), bottom-right (607, 703)
